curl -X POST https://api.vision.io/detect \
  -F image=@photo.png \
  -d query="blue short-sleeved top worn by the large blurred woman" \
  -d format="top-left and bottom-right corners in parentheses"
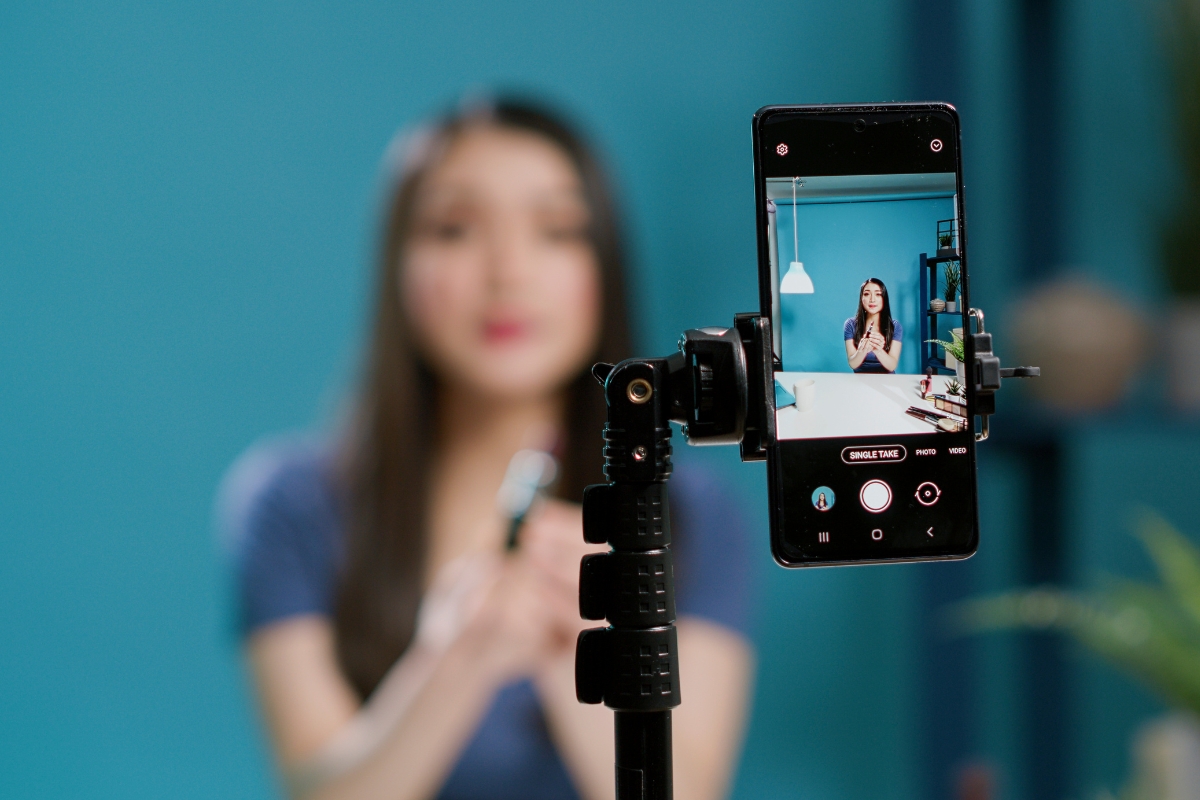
top-left (221, 441), bottom-right (751, 800)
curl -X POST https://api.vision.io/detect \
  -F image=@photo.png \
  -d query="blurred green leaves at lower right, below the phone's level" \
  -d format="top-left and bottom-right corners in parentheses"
top-left (950, 512), bottom-right (1200, 715)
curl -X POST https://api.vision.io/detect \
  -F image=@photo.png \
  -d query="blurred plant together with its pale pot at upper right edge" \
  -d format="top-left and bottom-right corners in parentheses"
top-left (1162, 0), bottom-right (1200, 413)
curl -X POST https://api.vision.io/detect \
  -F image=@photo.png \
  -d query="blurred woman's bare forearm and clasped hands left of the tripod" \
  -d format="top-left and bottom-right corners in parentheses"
top-left (251, 515), bottom-right (588, 800)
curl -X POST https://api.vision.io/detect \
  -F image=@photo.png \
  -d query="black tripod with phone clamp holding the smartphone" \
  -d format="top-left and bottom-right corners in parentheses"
top-left (575, 308), bottom-right (1038, 800)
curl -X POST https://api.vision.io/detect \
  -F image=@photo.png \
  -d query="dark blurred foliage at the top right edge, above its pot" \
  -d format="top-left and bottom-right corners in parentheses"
top-left (1162, 0), bottom-right (1200, 297)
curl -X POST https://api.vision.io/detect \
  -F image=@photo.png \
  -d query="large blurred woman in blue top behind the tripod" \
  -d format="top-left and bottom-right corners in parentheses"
top-left (222, 102), bottom-right (751, 800)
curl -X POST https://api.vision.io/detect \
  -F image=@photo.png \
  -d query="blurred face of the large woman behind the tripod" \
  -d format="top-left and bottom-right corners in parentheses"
top-left (400, 126), bottom-right (601, 399)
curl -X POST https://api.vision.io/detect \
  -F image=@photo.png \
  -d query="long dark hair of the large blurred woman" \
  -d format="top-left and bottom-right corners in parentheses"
top-left (334, 100), bottom-right (630, 699)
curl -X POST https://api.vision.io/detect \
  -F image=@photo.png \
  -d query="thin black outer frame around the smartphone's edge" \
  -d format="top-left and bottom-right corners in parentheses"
top-left (752, 102), bottom-right (979, 569)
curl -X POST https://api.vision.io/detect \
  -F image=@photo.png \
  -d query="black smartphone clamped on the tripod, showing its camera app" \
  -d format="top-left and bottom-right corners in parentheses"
top-left (754, 103), bottom-right (979, 567)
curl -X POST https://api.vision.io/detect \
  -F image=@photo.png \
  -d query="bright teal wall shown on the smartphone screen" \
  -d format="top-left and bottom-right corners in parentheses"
top-left (776, 197), bottom-right (954, 373)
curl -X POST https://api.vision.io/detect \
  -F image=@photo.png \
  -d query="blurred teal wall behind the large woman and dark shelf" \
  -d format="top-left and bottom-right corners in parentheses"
top-left (0, 0), bottom-right (1185, 800)
